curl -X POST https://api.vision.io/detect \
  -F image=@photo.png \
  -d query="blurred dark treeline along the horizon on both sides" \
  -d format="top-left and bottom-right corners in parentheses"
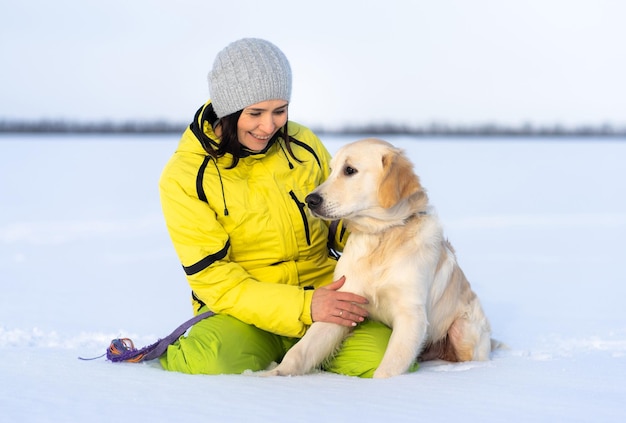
top-left (0, 120), bottom-right (626, 137)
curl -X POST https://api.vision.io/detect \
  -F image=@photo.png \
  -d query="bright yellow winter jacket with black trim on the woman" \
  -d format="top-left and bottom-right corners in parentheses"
top-left (159, 103), bottom-right (342, 337)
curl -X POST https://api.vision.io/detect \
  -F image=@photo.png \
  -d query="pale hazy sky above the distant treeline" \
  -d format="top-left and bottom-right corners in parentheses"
top-left (0, 0), bottom-right (626, 127)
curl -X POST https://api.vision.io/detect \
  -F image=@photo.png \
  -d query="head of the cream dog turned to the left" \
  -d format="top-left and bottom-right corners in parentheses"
top-left (306, 138), bottom-right (427, 227)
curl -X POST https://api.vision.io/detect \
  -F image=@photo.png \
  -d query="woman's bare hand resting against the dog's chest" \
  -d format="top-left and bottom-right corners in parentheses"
top-left (311, 276), bottom-right (368, 326)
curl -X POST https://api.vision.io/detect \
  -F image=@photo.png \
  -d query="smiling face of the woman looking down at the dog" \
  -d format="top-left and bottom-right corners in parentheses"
top-left (237, 100), bottom-right (289, 151)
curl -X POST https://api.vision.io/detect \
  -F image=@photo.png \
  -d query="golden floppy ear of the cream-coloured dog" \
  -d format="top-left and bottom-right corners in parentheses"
top-left (378, 150), bottom-right (422, 209)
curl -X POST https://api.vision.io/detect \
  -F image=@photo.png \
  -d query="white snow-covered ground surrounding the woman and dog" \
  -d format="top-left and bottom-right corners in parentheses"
top-left (0, 136), bottom-right (626, 422)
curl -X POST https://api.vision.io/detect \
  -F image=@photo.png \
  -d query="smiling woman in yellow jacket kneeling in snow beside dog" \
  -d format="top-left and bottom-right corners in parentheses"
top-left (160, 39), bottom-right (410, 377)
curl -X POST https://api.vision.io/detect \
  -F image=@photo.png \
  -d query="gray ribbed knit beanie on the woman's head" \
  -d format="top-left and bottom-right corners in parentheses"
top-left (209, 38), bottom-right (291, 118)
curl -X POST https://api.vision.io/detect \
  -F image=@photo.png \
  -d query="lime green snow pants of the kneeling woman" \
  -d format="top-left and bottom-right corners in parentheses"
top-left (159, 310), bottom-right (418, 378)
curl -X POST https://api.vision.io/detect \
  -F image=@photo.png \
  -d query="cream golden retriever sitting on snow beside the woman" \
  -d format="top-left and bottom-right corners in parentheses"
top-left (267, 138), bottom-right (492, 378)
